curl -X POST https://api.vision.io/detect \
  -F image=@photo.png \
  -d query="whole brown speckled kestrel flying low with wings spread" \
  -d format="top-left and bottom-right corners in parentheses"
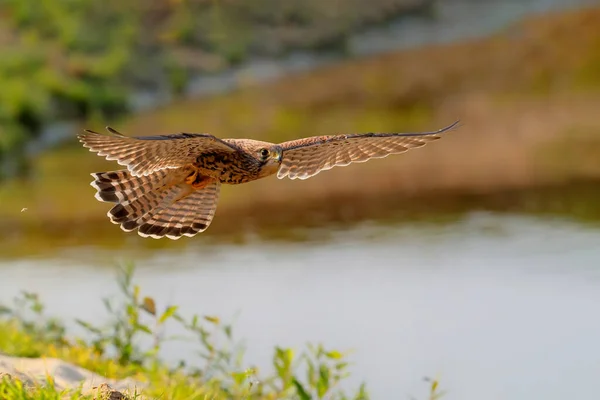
top-left (78, 121), bottom-right (459, 239)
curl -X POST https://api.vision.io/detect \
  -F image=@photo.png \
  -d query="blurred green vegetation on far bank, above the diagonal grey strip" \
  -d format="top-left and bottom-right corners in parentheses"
top-left (0, 0), bottom-right (434, 178)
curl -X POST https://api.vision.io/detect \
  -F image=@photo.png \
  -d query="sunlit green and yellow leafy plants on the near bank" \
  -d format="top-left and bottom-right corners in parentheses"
top-left (0, 265), bottom-right (382, 400)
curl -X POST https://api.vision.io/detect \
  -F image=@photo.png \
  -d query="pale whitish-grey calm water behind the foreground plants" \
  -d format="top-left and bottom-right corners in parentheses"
top-left (0, 214), bottom-right (600, 400)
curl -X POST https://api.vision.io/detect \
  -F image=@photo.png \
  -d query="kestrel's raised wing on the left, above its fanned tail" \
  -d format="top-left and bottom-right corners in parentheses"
top-left (77, 127), bottom-right (236, 176)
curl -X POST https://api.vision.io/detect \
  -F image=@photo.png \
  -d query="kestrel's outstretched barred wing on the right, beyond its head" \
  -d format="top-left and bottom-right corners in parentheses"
top-left (277, 121), bottom-right (459, 179)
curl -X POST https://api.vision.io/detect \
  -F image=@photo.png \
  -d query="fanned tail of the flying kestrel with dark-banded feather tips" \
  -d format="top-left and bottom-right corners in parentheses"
top-left (91, 170), bottom-right (220, 239)
